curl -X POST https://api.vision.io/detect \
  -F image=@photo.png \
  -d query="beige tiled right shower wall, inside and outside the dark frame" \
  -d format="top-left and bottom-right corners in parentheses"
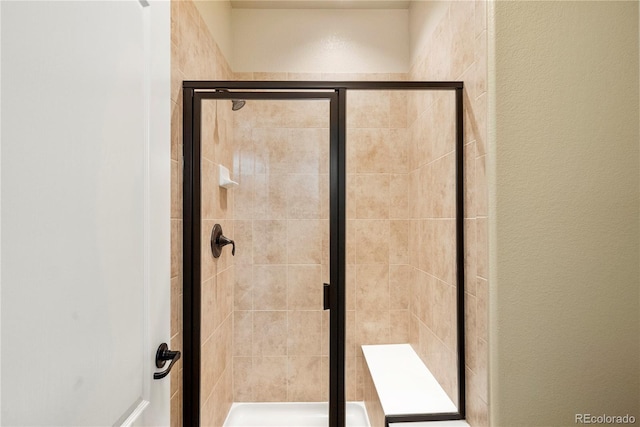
top-left (409, 1), bottom-right (489, 426)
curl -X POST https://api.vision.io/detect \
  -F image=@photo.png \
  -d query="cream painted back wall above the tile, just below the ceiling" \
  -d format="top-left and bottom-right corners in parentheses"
top-left (231, 9), bottom-right (409, 73)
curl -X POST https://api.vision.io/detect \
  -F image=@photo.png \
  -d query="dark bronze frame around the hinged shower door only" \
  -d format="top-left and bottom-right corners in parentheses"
top-left (183, 86), bottom-right (346, 426)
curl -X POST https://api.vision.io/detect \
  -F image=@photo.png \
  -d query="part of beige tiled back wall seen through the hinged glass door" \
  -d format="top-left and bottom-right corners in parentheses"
top-left (233, 98), bottom-right (329, 402)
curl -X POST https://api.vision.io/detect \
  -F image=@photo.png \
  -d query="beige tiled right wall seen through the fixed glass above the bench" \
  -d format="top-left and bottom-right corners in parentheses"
top-left (408, 88), bottom-right (458, 402)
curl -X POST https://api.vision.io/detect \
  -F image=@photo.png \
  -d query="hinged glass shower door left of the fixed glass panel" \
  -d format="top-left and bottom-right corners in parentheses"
top-left (185, 90), bottom-right (343, 426)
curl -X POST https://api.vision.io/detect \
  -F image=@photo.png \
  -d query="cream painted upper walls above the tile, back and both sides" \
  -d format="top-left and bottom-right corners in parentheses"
top-left (195, 0), bottom-right (449, 73)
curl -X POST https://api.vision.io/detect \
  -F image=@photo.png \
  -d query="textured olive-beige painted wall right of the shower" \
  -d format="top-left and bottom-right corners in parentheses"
top-left (488, 2), bottom-right (640, 426)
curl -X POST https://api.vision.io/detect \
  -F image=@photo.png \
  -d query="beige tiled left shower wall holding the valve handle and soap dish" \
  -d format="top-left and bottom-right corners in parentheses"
top-left (171, 0), bottom-right (234, 427)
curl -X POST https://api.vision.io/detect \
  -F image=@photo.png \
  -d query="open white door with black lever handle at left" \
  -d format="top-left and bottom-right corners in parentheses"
top-left (0, 0), bottom-right (170, 426)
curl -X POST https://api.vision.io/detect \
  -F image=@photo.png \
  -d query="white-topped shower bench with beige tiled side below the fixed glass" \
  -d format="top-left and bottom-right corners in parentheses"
top-left (362, 344), bottom-right (469, 427)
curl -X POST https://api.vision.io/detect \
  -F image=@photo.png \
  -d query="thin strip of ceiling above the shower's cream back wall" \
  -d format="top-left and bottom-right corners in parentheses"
top-left (231, 0), bottom-right (410, 9)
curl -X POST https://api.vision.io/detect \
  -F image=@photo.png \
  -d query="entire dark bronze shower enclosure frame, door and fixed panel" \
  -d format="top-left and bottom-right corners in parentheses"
top-left (182, 81), bottom-right (466, 427)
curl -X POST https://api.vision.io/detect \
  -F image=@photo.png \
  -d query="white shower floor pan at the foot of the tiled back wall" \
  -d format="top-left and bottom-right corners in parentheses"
top-left (224, 402), bottom-right (370, 427)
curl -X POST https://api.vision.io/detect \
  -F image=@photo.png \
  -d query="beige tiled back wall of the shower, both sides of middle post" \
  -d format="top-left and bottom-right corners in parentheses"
top-left (228, 73), bottom-right (410, 401)
